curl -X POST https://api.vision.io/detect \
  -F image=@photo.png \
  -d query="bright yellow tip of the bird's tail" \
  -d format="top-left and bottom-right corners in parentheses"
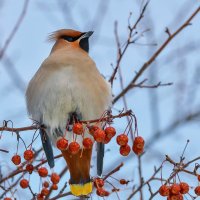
top-left (70, 182), bottom-right (92, 196)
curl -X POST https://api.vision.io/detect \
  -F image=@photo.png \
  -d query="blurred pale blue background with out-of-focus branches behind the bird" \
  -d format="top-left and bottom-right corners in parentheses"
top-left (0, 0), bottom-right (200, 200)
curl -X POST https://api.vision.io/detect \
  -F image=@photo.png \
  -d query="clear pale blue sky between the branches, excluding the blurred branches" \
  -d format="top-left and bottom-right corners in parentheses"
top-left (0, 0), bottom-right (200, 200)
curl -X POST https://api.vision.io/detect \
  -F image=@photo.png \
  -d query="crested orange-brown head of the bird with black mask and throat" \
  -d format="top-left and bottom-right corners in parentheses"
top-left (49, 29), bottom-right (93, 53)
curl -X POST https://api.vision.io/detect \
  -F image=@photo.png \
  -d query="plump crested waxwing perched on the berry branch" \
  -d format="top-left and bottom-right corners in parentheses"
top-left (26, 29), bottom-right (112, 196)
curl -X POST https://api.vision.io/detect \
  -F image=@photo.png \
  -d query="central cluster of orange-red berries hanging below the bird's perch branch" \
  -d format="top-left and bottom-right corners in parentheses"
top-left (57, 123), bottom-right (145, 156)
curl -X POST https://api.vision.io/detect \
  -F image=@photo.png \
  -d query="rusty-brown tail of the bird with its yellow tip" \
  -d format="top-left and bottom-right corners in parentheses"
top-left (62, 149), bottom-right (92, 196)
